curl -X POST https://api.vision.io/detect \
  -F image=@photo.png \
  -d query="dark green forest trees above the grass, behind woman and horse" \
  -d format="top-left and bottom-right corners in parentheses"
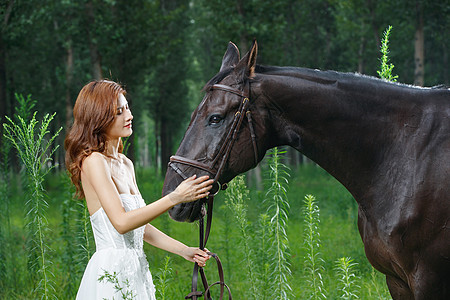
top-left (0, 0), bottom-right (450, 173)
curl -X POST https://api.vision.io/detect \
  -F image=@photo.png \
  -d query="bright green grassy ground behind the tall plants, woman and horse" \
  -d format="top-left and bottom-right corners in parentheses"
top-left (0, 164), bottom-right (390, 299)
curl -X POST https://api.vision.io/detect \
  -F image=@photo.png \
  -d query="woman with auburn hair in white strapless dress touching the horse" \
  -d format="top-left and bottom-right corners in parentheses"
top-left (64, 80), bottom-right (213, 300)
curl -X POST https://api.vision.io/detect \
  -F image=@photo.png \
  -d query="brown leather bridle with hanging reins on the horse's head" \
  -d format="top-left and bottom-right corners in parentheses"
top-left (169, 80), bottom-right (258, 300)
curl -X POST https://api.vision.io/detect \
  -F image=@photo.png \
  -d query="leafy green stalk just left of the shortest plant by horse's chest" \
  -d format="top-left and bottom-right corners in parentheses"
top-left (303, 195), bottom-right (326, 299)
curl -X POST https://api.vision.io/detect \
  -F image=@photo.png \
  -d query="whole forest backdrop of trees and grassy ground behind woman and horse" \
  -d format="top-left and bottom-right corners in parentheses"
top-left (0, 0), bottom-right (450, 299)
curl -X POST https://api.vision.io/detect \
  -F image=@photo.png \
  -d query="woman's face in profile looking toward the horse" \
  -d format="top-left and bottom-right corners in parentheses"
top-left (106, 94), bottom-right (133, 139)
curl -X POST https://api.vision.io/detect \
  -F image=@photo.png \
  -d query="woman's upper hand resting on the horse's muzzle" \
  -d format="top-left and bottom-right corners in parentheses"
top-left (170, 175), bottom-right (214, 204)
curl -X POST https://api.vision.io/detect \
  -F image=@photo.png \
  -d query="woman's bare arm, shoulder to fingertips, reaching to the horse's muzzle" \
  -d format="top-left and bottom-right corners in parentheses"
top-left (81, 152), bottom-right (213, 234)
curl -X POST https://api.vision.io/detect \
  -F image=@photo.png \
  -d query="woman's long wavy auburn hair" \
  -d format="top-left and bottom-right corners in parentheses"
top-left (64, 80), bottom-right (126, 199)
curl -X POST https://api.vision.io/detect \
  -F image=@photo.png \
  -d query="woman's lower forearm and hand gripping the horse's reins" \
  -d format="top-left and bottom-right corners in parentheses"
top-left (144, 224), bottom-right (210, 267)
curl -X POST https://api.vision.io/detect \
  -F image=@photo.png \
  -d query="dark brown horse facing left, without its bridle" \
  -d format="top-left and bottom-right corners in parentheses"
top-left (163, 42), bottom-right (450, 300)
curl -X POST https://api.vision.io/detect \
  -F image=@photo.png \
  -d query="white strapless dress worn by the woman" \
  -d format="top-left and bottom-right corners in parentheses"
top-left (76, 194), bottom-right (156, 300)
